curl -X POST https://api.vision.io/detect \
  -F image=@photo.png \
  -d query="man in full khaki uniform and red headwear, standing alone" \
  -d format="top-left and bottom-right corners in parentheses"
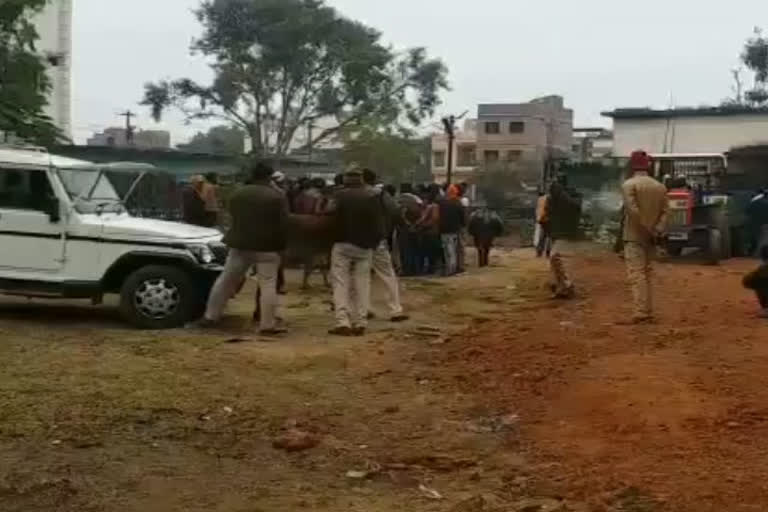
top-left (622, 151), bottom-right (668, 323)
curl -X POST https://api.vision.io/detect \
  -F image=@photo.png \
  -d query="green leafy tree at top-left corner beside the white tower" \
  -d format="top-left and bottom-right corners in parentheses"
top-left (0, 0), bottom-right (62, 146)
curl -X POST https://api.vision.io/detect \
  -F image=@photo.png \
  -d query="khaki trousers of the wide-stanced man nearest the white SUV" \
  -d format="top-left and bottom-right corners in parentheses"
top-left (205, 249), bottom-right (280, 330)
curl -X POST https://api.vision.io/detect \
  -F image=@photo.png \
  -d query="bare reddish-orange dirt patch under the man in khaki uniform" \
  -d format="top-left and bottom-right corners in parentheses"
top-left (440, 250), bottom-right (768, 512)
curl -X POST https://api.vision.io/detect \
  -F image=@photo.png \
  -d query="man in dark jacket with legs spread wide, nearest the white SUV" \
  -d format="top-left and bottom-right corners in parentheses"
top-left (198, 163), bottom-right (288, 335)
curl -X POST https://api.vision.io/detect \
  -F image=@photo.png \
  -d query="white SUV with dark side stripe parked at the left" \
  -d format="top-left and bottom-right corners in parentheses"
top-left (0, 148), bottom-right (226, 329)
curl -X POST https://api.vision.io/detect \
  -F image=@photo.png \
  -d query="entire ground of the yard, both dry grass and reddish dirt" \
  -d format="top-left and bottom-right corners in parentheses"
top-left (0, 247), bottom-right (768, 512)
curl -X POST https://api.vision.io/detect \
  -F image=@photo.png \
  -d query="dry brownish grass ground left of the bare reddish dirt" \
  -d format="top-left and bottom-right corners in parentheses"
top-left (0, 256), bottom-right (540, 512)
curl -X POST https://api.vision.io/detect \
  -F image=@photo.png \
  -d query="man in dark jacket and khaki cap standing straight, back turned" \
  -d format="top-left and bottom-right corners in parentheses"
top-left (329, 168), bottom-right (385, 336)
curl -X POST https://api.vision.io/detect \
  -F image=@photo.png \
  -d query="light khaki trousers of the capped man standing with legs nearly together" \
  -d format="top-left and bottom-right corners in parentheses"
top-left (331, 243), bottom-right (373, 327)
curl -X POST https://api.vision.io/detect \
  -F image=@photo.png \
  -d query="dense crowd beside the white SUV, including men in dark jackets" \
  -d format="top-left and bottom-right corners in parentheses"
top-left (184, 162), bottom-right (503, 336)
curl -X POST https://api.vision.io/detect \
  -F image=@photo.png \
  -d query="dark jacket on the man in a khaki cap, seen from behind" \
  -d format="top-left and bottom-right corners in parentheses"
top-left (333, 186), bottom-right (386, 249)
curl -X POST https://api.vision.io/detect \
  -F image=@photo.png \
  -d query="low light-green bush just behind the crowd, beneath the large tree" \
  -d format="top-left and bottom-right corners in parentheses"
top-left (342, 127), bottom-right (427, 183)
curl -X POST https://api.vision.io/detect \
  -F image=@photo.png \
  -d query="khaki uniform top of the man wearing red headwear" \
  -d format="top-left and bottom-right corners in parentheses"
top-left (622, 174), bottom-right (669, 244)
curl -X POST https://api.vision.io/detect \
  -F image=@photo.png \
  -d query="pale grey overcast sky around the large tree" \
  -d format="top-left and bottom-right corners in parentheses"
top-left (73, 0), bottom-right (768, 144)
